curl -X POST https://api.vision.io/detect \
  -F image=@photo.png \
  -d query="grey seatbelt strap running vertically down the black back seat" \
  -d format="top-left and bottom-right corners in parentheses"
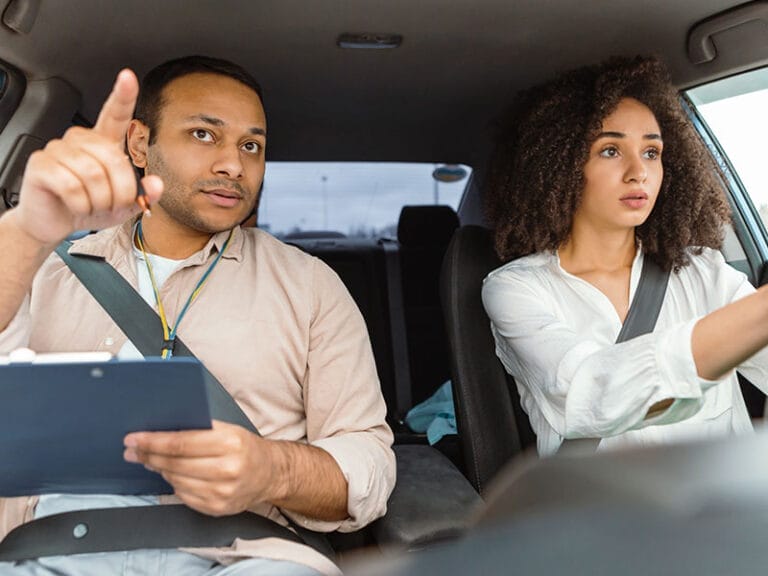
top-left (379, 238), bottom-right (412, 422)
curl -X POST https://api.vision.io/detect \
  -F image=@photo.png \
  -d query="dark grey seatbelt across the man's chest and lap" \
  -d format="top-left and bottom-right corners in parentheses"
top-left (0, 241), bottom-right (334, 562)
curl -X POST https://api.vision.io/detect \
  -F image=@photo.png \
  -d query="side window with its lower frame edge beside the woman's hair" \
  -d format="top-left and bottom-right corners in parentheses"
top-left (685, 68), bottom-right (768, 283)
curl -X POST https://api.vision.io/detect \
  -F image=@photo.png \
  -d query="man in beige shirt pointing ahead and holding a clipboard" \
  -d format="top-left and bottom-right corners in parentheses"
top-left (0, 57), bottom-right (394, 574)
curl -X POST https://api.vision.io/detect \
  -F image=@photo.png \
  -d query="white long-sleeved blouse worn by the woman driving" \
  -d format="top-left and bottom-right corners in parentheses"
top-left (483, 249), bottom-right (768, 455)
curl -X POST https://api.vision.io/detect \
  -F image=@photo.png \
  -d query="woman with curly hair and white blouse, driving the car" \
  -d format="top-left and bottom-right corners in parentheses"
top-left (483, 58), bottom-right (768, 455)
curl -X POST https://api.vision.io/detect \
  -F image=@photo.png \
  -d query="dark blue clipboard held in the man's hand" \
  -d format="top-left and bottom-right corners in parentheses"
top-left (0, 358), bottom-right (211, 497)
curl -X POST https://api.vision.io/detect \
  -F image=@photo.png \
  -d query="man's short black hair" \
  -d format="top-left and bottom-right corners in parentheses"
top-left (133, 56), bottom-right (264, 144)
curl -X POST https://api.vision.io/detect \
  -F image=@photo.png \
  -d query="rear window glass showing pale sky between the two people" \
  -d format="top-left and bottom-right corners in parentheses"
top-left (258, 162), bottom-right (471, 238)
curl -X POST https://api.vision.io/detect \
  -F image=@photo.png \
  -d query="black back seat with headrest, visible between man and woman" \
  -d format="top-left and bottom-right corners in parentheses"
top-left (285, 206), bottom-right (458, 431)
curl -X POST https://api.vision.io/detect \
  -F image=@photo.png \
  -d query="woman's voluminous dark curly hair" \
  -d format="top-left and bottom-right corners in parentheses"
top-left (485, 56), bottom-right (730, 271)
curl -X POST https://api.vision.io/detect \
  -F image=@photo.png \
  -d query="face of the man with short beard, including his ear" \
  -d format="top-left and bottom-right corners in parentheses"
top-left (141, 73), bottom-right (266, 234)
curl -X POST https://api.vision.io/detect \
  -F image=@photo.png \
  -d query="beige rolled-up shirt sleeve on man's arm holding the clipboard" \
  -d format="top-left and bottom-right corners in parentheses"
top-left (286, 262), bottom-right (395, 532)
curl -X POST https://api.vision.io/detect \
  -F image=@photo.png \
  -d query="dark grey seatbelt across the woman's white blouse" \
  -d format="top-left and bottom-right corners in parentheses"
top-left (558, 255), bottom-right (669, 456)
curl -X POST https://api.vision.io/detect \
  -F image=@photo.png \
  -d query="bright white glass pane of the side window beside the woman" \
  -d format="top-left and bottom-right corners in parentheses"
top-left (687, 68), bottom-right (768, 226)
